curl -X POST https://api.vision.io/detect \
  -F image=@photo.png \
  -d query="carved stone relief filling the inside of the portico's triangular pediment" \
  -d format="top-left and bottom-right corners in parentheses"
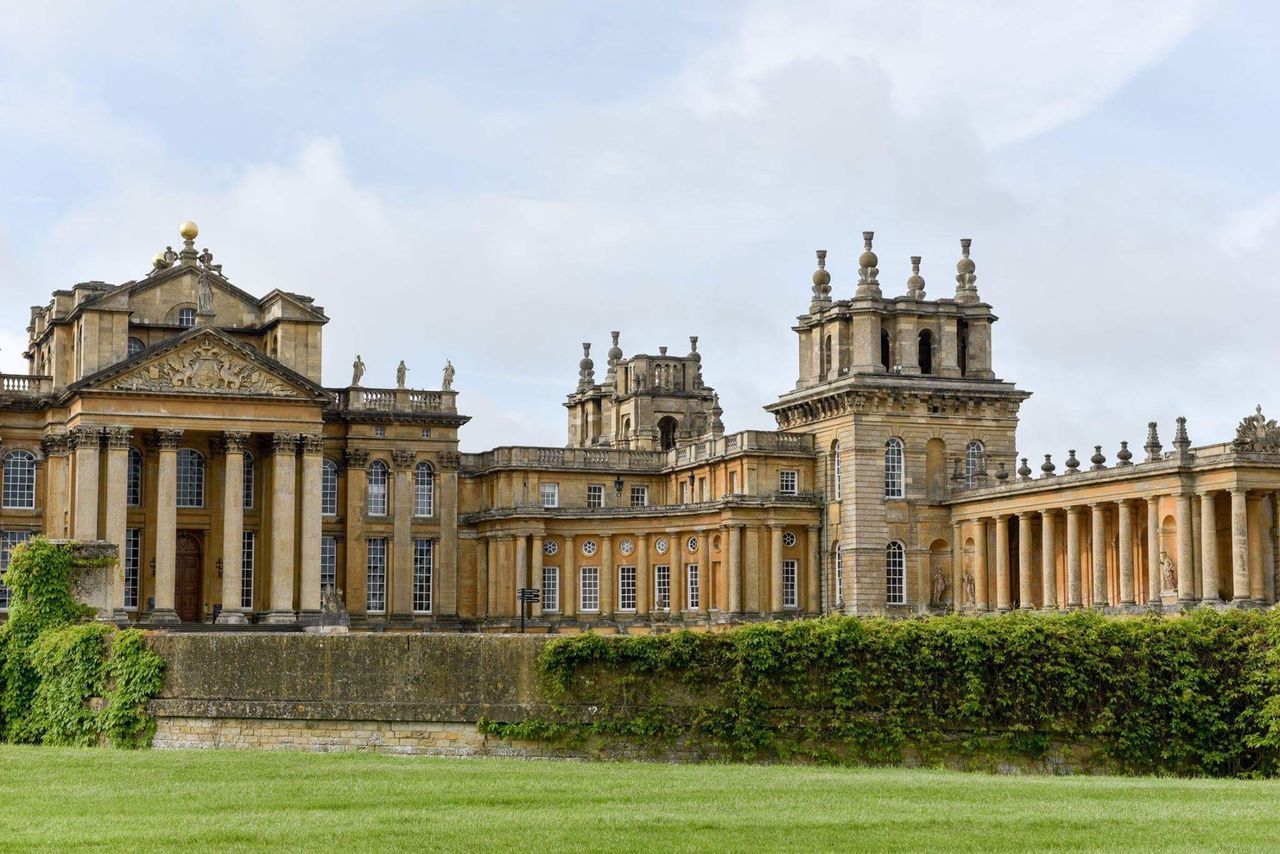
top-left (110, 339), bottom-right (306, 397)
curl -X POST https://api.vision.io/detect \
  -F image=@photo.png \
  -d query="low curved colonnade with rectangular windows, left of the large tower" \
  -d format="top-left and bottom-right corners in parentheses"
top-left (475, 522), bottom-right (822, 622)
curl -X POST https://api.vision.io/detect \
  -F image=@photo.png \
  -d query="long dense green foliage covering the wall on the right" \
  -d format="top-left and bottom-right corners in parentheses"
top-left (481, 609), bottom-right (1280, 776)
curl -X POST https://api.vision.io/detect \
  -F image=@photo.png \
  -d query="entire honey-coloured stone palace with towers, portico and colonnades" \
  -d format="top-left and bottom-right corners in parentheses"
top-left (0, 223), bottom-right (1280, 631)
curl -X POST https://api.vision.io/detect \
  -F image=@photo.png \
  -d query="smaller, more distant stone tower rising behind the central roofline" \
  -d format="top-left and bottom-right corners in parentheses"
top-left (564, 332), bottom-right (724, 451)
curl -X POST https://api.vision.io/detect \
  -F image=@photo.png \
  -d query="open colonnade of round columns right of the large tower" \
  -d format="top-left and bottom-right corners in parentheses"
top-left (950, 488), bottom-right (1280, 611)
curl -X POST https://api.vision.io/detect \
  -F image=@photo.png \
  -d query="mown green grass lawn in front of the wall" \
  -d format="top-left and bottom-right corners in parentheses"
top-left (0, 746), bottom-right (1280, 853)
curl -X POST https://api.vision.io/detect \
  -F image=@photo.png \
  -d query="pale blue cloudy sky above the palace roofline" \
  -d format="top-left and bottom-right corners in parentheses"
top-left (0, 0), bottom-right (1280, 463)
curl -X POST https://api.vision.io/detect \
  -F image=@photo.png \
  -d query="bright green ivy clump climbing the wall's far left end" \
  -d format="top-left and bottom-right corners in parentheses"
top-left (0, 538), bottom-right (164, 748)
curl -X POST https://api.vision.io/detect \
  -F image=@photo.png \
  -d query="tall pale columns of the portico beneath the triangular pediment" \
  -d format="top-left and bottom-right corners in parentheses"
top-left (68, 425), bottom-right (324, 624)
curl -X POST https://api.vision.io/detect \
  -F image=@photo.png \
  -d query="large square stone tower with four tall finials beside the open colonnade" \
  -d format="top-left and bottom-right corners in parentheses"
top-left (765, 232), bottom-right (1030, 613)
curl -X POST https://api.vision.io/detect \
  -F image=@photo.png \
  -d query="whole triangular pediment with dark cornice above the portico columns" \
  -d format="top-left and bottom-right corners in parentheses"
top-left (72, 326), bottom-right (328, 401)
